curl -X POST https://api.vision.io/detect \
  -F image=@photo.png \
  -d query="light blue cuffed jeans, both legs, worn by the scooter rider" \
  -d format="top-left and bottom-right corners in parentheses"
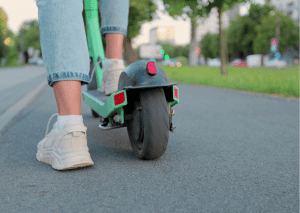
top-left (36, 0), bottom-right (129, 87)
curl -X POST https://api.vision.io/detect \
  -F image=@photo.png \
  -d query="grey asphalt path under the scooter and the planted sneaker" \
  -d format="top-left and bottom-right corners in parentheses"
top-left (0, 67), bottom-right (299, 213)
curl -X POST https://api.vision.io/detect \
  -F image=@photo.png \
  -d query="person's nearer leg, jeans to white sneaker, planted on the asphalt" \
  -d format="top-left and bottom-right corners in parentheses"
top-left (36, 0), bottom-right (94, 170)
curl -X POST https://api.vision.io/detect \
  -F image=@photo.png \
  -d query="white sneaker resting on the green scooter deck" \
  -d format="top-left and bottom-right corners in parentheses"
top-left (100, 59), bottom-right (125, 95)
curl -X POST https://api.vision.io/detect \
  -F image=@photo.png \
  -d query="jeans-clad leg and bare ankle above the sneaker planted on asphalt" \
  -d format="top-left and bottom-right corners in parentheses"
top-left (37, 0), bottom-right (90, 116)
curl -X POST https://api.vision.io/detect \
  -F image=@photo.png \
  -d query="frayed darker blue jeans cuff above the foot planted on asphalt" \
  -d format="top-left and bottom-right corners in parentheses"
top-left (47, 71), bottom-right (90, 87)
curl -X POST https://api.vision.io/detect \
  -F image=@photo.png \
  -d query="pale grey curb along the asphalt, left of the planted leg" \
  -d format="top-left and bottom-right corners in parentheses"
top-left (0, 81), bottom-right (47, 132)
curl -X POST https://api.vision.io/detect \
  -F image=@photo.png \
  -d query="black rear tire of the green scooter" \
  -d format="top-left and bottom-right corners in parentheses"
top-left (127, 88), bottom-right (170, 160)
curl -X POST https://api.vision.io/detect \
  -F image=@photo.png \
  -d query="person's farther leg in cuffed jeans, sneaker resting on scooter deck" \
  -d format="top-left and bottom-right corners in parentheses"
top-left (99, 0), bottom-right (129, 95)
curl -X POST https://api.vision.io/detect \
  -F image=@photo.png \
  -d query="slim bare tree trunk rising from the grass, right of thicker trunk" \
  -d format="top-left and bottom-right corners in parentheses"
top-left (218, 7), bottom-right (228, 75)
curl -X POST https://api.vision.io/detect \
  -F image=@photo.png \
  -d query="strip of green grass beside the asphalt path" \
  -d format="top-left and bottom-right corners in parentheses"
top-left (162, 66), bottom-right (299, 97)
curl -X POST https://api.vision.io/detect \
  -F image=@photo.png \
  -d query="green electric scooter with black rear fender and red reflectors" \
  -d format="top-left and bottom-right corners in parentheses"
top-left (82, 0), bottom-right (179, 160)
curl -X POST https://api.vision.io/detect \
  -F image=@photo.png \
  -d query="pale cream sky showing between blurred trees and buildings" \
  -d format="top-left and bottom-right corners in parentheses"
top-left (0, 0), bottom-right (264, 47)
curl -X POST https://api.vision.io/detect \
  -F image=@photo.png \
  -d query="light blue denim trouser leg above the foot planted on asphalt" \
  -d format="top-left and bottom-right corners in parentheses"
top-left (36, 0), bottom-right (90, 87)
